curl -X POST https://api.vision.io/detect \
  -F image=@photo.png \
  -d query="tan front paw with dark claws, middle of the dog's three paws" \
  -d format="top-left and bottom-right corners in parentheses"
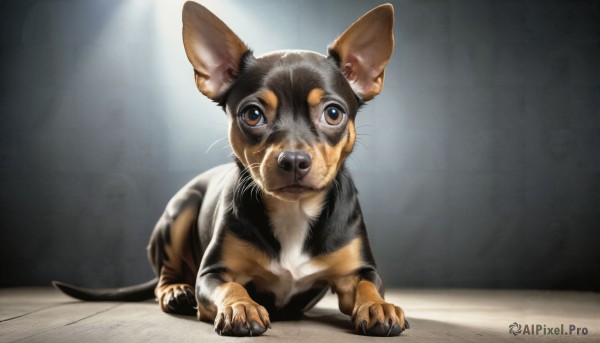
top-left (215, 300), bottom-right (271, 336)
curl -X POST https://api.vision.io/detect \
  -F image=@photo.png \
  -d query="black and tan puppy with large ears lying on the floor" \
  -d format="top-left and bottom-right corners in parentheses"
top-left (54, 2), bottom-right (409, 336)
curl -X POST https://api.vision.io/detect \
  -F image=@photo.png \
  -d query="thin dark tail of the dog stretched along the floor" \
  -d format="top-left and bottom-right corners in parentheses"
top-left (52, 278), bottom-right (158, 301)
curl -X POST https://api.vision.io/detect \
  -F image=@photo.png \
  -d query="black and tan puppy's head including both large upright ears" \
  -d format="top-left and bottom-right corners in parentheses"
top-left (183, 2), bottom-right (394, 200)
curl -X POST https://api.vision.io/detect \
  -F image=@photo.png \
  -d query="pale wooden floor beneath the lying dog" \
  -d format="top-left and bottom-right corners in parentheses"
top-left (0, 288), bottom-right (600, 343)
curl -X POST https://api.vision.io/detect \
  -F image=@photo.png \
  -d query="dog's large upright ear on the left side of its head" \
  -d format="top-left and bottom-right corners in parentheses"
top-left (182, 1), bottom-right (249, 101)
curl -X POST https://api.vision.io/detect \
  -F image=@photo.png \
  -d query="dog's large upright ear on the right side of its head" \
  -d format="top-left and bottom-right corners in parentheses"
top-left (329, 4), bottom-right (394, 101)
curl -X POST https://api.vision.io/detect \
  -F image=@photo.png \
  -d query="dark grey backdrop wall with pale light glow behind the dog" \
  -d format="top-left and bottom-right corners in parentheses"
top-left (0, 0), bottom-right (600, 291)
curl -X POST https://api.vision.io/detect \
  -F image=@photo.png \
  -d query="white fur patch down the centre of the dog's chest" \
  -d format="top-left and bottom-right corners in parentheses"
top-left (269, 194), bottom-right (324, 307)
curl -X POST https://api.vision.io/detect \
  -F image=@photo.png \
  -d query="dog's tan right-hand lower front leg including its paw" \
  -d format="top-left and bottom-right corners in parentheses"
top-left (332, 269), bottom-right (409, 336)
